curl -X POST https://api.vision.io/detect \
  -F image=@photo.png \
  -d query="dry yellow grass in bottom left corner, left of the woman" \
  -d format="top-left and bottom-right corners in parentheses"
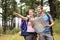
top-left (0, 34), bottom-right (24, 40)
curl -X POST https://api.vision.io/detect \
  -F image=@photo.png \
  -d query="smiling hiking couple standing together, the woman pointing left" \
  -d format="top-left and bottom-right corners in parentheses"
top-left (13, 5), bottom-right (54, 40)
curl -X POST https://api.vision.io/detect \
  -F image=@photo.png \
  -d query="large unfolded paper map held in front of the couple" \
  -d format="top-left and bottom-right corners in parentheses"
top-left (31, 17), bottom-right (46, 33)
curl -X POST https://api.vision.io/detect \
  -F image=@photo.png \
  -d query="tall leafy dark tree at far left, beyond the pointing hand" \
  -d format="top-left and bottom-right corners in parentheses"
top-left (1, 0), bottom-right (17, 33)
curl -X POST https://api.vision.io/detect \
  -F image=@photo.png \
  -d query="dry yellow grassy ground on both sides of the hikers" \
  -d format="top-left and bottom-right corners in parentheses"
top-left (0, 33), bottom-right (60, 40)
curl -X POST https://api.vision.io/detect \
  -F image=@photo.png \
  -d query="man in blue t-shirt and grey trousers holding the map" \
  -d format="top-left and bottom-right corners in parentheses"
top-left (37, 5), bottom-right (54, 40)
